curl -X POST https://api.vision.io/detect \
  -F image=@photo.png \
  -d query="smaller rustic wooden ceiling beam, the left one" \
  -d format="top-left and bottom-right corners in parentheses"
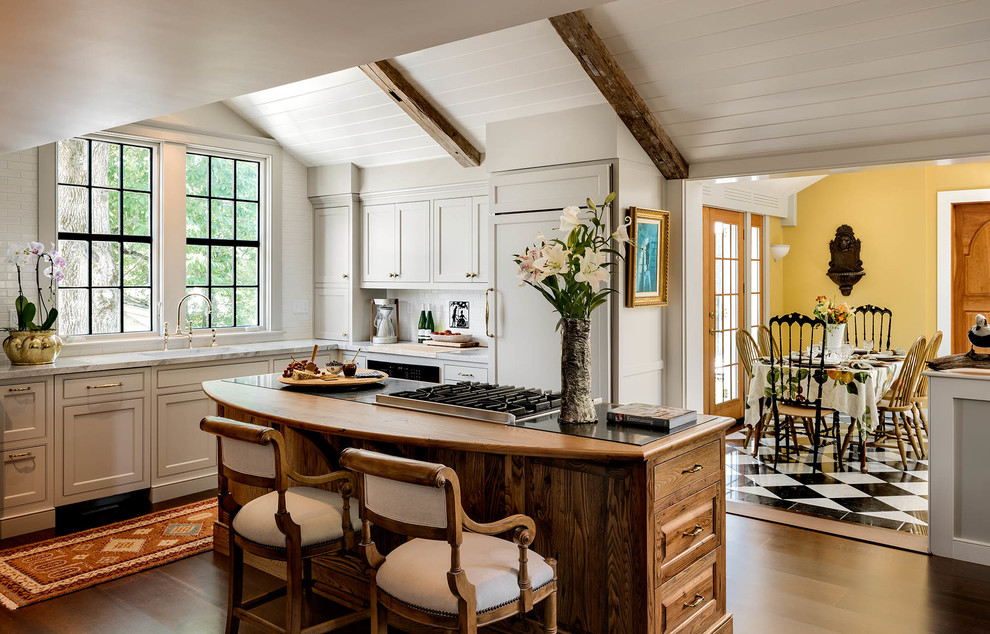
top-left (360, 60), bottom-right (481, 167)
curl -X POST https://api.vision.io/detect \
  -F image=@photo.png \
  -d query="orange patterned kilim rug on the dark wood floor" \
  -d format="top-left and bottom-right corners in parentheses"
top-left (0, 498), bottom-right (217, 610)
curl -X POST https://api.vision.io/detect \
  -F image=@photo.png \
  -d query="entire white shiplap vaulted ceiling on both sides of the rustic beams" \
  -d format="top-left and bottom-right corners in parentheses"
top-left (228, 0), bottom-right (990, 166)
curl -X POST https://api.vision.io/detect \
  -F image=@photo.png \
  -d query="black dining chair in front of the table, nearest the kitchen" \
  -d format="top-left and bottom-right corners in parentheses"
top-left (769, 313), bottom-right (842, 468)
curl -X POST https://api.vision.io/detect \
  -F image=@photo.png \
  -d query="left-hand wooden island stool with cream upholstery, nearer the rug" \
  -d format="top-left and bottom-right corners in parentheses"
top-left (199, 416), bottom-right (369, 634)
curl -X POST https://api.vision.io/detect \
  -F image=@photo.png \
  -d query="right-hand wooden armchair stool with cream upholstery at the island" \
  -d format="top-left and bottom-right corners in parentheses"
top-left (340, 448), bottom-right (557, 634)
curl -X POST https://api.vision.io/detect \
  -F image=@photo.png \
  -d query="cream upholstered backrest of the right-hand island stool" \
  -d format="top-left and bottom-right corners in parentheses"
top-left (340, 448), bottom-right (463, 544)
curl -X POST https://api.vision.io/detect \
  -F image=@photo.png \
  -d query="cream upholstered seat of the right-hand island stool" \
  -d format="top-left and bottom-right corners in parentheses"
top-left (376, 531), bottom-right (554, 616)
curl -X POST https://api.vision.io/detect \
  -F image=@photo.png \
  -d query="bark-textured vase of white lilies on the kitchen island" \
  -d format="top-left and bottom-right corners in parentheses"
top-left (514, 192), bottom-right (631, 423)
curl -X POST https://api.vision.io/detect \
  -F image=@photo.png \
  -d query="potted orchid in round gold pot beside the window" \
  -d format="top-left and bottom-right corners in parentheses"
top-left (3, 242), bottom-right (66, 365)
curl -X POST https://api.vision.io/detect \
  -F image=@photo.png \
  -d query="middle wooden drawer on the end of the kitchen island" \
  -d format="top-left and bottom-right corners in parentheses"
top-left (656, 484), bottom-right (723, 586)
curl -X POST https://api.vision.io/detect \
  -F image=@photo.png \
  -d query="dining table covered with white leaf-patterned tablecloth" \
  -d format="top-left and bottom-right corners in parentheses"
top-left (745, 353), bottom-right (904, 473)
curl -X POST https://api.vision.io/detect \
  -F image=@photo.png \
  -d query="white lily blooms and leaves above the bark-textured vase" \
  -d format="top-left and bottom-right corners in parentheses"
top-left (515, 192), bottom-right (631, 325)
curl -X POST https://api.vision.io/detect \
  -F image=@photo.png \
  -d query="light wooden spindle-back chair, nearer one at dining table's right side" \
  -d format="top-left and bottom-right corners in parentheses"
top-left (870, 336), bottom-right (927, 469)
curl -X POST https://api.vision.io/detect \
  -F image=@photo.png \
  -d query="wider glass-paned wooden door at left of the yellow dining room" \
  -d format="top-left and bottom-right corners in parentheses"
top-left (704, 207), bottom-right (750, 418)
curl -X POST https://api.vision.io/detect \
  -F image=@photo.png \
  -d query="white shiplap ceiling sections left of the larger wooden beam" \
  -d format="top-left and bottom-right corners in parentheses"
top-left (226, 20), bottom-right (604, 167)
